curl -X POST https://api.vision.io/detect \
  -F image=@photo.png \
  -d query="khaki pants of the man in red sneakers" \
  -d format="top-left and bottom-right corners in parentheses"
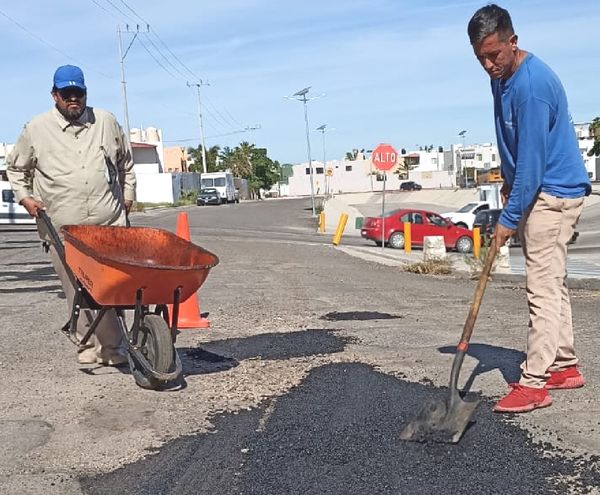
top-left (519, 193), bottom-right (583, 388)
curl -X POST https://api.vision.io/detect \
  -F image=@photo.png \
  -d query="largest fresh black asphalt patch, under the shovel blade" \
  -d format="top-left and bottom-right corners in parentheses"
top-left (80, 363), bottom-right (600, 495)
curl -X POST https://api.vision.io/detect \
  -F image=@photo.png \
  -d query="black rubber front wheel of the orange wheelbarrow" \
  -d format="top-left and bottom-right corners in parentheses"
top-left (129, 315), bottom-right (175, 390)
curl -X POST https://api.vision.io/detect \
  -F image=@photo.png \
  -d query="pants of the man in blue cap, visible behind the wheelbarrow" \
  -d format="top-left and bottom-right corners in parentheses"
top-left (49, 246), bottom-right (125, 358)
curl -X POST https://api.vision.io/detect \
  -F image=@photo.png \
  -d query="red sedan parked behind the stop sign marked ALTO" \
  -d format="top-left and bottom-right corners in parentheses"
top-left (360, 209), bottom-right (473, 253)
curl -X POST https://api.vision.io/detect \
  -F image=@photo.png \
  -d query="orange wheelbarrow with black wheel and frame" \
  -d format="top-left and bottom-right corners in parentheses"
top-left (40, 211), bottom-right (219, 390)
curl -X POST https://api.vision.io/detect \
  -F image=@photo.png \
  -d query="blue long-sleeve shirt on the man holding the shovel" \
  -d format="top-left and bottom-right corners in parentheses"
top-left (491, 53), bottom-right (591, 229)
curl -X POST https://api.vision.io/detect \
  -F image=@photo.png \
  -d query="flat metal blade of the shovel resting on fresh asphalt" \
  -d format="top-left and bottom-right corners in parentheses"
top-left (400, 393), bottom-right (479, 443)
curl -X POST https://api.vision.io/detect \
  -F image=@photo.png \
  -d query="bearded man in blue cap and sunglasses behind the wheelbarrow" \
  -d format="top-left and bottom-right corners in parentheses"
top-left (7, 65), bottom-right (136, 365)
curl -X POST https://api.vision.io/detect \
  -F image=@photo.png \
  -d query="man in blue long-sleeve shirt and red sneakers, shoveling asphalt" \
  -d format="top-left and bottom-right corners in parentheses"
top-left (468, 4), bottom-right (591, 412)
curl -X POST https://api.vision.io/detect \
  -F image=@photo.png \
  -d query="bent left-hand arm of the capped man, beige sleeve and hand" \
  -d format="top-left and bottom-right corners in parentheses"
top-left (6, 126), bottom-right (44, 217)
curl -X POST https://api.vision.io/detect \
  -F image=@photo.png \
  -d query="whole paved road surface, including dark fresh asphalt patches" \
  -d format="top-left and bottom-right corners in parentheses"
top-left (0, 199), bottom-right (600, 495)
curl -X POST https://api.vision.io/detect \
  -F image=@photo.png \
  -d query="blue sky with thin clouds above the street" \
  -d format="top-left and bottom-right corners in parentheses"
top-left (0, 0), bottom-right (600, 163)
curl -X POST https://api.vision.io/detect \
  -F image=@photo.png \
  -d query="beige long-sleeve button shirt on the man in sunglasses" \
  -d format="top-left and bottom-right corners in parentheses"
top-left (7, 107), bottom-right (136, 237)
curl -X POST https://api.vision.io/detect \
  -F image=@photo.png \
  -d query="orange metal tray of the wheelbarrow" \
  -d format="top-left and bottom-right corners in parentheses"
top-left (61, 225), bottom-right (219, 306)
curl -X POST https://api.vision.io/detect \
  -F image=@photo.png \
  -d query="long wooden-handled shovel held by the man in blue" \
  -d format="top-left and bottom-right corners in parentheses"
top-left (400, 237), bottom-right (498, 443)
